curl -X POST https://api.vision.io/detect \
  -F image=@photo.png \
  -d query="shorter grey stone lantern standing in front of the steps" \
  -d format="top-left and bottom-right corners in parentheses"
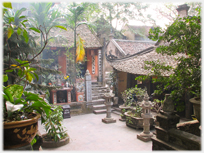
top-left (102, 92), bottom-right (116, 123)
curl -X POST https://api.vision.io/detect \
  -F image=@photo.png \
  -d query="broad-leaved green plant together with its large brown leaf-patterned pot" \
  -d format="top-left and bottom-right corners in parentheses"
top-left (3, 75), bottom-right (51, 149)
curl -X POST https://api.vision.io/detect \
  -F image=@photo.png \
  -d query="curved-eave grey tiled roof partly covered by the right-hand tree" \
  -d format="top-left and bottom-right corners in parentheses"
top-left (108, 47), bottom-right (186, 76)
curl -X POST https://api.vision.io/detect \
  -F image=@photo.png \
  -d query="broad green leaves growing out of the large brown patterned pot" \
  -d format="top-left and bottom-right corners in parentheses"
top-left (3, 81), bottom-right (51, 123)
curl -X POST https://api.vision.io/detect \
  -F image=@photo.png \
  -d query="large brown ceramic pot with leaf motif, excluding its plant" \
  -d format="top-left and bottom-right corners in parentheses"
top-left (4, 114), bottom-right (40, 149)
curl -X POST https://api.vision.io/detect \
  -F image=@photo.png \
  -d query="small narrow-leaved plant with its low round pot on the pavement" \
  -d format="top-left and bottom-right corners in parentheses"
top-left (42, 105), bottom-right (69, 148)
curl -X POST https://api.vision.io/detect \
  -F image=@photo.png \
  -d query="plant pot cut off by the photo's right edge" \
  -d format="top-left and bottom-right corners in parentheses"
top-left (189, 98), bottom-right (201, 123)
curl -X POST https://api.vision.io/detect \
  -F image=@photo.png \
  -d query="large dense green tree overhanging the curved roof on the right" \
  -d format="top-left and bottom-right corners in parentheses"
top-left (136, 7), bottom-right (201, 111)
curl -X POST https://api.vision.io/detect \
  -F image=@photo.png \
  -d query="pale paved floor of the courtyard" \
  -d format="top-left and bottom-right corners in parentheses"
top-left (38, 113), bottom-right (154, 152)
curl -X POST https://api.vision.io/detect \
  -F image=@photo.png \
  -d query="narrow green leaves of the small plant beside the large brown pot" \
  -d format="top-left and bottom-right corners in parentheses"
top-left (44, 105), bottom-right (67, 141)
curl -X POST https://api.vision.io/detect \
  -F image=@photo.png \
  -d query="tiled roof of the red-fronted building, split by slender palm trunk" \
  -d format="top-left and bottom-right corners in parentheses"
top-left (42, 24), bottom-right (102, 48)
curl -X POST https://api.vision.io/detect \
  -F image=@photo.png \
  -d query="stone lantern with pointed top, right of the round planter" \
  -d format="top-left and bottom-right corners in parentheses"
top-left (137, 92), bottom-right (153, 142)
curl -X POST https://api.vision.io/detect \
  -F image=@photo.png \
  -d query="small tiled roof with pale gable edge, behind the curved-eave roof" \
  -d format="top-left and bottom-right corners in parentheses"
top-left (115, 39), bottom-right (155, 55)
